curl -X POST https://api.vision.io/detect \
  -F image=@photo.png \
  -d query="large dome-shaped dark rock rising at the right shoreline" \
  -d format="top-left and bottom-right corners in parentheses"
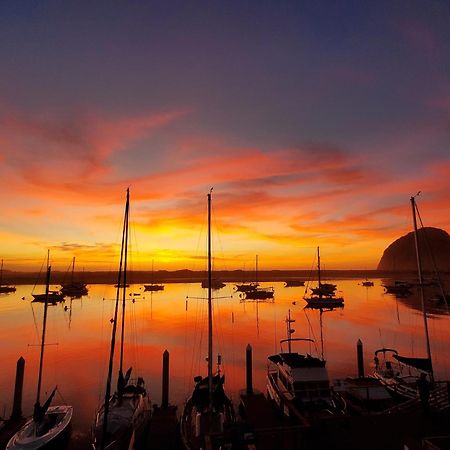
top-left (377, 227), bottom-right (450, 272)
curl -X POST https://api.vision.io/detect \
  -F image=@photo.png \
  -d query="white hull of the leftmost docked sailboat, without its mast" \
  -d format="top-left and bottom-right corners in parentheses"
top-left (6, 406), bottom-right (73, 450)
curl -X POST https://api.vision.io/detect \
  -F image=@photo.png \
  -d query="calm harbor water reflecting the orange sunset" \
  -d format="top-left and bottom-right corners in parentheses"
top-left (0, 280), bottom-right (450, 448)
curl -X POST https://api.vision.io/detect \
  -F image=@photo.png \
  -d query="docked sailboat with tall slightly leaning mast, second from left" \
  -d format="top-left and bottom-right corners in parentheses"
top-left (92, 189), bottom-right (151, 450)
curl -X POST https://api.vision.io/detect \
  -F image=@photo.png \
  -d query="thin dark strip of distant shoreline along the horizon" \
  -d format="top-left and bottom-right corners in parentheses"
top-left (2, 270), bottom-right (448, 285)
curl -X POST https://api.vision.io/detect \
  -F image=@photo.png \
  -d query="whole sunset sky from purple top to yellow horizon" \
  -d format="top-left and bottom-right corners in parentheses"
top-left (0, 0), bottom-right (450, 270)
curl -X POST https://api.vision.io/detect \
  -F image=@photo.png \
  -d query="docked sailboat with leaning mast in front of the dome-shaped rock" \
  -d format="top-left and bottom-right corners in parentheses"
top-left (373, 194), bottom-right (440, 400)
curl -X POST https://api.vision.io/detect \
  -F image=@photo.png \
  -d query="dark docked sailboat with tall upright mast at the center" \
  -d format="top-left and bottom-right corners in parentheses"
top-left (180, 189), bottom-right (235, 450)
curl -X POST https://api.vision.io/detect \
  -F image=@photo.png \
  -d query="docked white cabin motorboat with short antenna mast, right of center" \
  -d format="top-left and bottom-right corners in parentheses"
top-left (267, 310), bottom-right (346, 420)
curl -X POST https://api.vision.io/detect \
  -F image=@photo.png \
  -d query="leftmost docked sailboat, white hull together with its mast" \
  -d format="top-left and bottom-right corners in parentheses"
top-left (6, 266), bottom-right (73, 450)
